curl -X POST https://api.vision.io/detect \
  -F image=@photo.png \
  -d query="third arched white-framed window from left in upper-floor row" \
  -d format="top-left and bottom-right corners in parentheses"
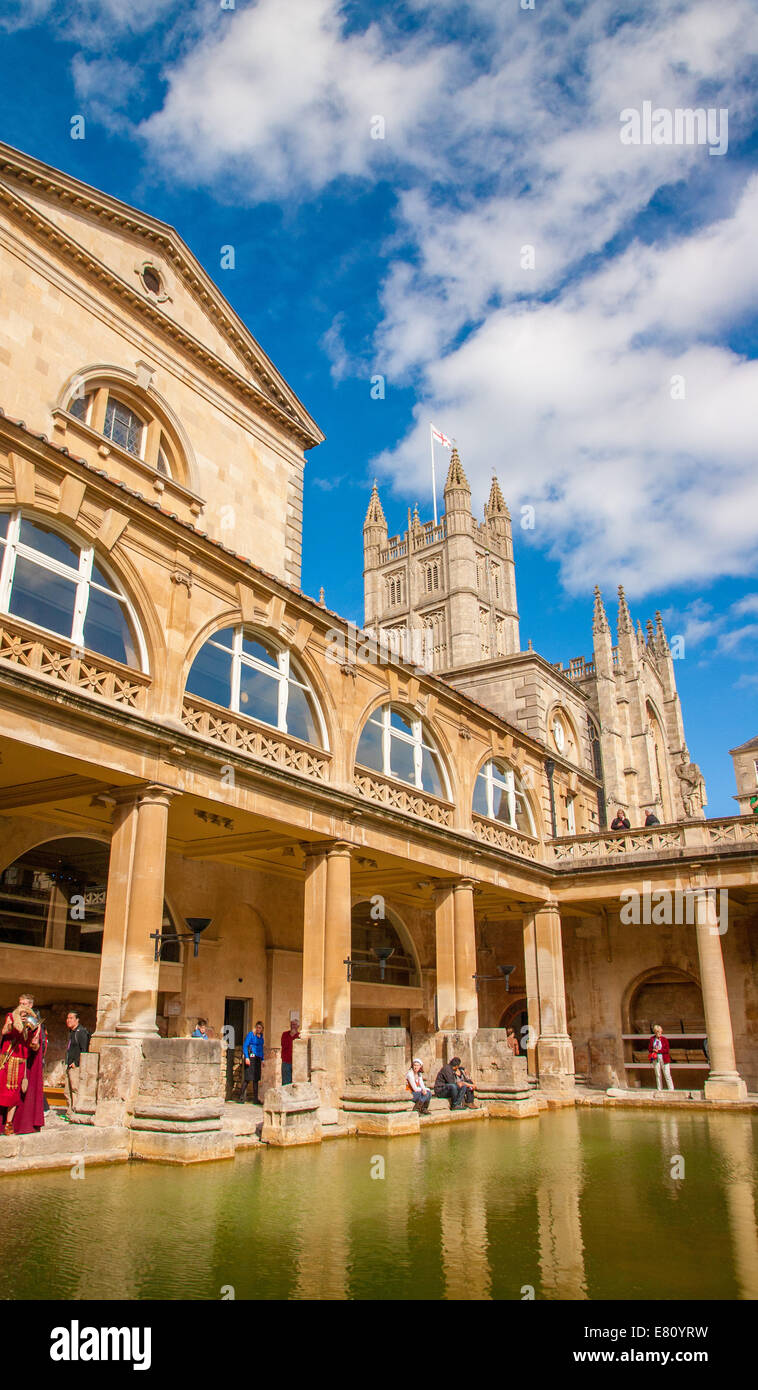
top-left (356, 705), bottom-right (449, 798)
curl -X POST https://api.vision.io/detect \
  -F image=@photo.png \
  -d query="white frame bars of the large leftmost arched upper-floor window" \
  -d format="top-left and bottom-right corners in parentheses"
top-left (0, 507), bottom-right (147, 671)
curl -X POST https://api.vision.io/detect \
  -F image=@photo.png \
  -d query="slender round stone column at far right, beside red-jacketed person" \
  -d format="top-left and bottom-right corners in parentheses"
top-left (695, 892), bottom-right (747, 1101)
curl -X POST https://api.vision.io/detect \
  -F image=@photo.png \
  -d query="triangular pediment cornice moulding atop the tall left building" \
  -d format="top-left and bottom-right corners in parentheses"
top-left (0, 157), bottom-right (324, 449)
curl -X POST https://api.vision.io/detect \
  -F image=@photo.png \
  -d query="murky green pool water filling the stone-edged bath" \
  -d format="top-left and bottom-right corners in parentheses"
top-left (0, 1111), bottom-right (758, 1300)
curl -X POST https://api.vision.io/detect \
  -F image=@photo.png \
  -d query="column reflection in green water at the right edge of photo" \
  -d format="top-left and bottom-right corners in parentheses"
top-left (708, 1115), bottom-right (758, 1298)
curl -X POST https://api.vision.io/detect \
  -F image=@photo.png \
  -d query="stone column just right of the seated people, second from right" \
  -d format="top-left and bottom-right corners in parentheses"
top-left (534, 898), bottom-right (574, 1093)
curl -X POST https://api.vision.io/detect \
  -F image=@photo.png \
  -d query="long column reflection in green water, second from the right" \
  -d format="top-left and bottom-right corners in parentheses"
top-left (534, 1106), bottom-right (587, 1298)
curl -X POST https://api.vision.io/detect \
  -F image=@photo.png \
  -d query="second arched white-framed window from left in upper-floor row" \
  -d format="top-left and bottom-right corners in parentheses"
top-left (186, 627), bottom-right (327, 748)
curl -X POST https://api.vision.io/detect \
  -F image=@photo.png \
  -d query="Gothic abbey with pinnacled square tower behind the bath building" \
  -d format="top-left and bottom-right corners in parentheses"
top-left (363, 449), bottom-right (707, 835)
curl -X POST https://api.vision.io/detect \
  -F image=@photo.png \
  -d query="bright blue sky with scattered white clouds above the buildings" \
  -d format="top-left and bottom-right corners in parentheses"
top-left (0, 0), bottom-right (758, 815)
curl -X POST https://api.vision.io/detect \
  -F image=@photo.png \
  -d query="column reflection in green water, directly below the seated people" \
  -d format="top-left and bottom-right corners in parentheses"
top-left (440, 1175), bottom-right (492, 1300)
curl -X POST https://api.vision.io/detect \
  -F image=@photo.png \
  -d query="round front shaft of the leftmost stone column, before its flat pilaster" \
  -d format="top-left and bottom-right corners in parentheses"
top-left (117, 785), bottom-right (175, 1038)
